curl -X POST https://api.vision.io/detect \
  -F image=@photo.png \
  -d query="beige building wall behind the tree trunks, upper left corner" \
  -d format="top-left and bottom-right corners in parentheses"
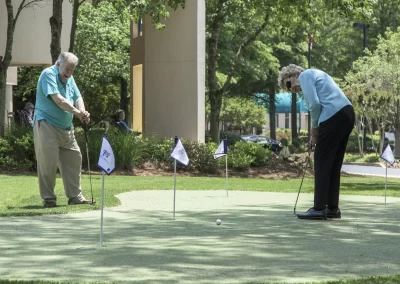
top-left (0, 0), bottom-right (72, 66)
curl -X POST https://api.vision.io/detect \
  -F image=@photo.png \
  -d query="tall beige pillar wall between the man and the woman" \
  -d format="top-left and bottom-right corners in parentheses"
top-left (131, 0), bottom-right (205, 142)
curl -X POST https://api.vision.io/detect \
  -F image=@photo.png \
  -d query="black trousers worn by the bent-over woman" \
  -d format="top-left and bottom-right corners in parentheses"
top-left (314, 105), bottom-right (355, 209)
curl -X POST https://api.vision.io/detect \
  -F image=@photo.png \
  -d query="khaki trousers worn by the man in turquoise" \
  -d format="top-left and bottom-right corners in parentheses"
top-left (33, 120), bottom-right (85, 201)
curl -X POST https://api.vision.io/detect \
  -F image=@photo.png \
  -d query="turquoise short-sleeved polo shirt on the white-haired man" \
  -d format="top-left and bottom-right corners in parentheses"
top-left (33, 65), bottom-right (81, 129)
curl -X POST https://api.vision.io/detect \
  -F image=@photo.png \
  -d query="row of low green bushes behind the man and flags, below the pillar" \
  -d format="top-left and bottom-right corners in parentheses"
top-left (0, 127), bottom-right (271, 174)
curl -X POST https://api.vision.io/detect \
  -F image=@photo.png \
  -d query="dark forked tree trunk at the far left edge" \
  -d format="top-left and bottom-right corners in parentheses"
top-left (0, 0), bottom-right (40, 136)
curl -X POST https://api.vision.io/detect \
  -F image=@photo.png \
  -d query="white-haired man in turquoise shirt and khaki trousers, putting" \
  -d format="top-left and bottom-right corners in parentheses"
top-left (33, 52), bottom-right (95, 208)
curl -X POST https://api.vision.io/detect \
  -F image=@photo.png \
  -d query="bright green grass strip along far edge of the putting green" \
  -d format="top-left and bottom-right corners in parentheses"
top-left (0, 174), bottom-right (400, 216)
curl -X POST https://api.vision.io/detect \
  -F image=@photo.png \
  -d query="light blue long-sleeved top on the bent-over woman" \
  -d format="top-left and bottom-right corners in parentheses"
top-left (299, 69), bottom-right (351, 128)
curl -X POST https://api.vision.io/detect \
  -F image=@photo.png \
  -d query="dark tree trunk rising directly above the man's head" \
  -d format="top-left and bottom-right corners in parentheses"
top-left (50, 0), bottom-right (63, 64)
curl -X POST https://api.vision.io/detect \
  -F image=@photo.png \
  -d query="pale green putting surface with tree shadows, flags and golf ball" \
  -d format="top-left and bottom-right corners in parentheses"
top-left (0, 191), bottom-right (400, 283)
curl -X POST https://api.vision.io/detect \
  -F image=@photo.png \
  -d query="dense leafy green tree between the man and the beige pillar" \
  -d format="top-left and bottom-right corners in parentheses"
top-left (70, 2), bottom-right (131, 120)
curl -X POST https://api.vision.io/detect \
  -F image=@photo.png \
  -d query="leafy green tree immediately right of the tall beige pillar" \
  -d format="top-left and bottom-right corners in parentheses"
top-left (206, 0), bottom-right (301, 142)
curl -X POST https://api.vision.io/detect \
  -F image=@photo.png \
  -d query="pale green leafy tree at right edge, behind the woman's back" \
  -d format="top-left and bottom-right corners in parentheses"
top-left (345, 29), bottom-right (400, 157)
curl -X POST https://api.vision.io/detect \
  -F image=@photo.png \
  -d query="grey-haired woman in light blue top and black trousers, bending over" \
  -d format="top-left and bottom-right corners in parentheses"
top-left (278, 64), bottom-right (355, 219)
